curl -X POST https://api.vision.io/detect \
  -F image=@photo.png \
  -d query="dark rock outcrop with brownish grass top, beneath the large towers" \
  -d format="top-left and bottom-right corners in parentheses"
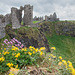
top-left (6, 26), bottom-right (50, 52)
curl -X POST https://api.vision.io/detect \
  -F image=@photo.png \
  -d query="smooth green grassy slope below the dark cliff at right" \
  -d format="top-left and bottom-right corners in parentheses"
top-left (46, 35), bottom-right (75, 67)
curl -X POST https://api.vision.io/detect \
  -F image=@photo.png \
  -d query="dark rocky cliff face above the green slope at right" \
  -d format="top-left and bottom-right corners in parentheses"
top-left (39, 21), bottom-right (75, 37)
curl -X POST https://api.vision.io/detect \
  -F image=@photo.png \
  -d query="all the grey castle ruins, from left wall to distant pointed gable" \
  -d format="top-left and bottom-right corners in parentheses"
top-left (0, 5), bottom-right (59, 39)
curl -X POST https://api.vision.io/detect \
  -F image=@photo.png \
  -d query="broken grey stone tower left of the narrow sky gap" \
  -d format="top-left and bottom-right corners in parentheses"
top-left (11, 7), bottom-right (21, 29)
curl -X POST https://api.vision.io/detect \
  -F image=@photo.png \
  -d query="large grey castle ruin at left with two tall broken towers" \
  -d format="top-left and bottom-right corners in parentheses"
top-left (0, 5), bottom-right (33, 39)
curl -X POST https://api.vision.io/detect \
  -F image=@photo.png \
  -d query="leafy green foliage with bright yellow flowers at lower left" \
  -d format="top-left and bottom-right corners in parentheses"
top-left (0, 41), bottom-right (43, 73)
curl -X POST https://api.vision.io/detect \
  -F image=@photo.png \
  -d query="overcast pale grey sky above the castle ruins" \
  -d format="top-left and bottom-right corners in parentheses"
top-left (0, 0), bottom-right (75, 20)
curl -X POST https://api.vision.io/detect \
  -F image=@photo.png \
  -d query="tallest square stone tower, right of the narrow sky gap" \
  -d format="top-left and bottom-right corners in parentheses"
top-left (23, 5), bottom-right (33, 25)
